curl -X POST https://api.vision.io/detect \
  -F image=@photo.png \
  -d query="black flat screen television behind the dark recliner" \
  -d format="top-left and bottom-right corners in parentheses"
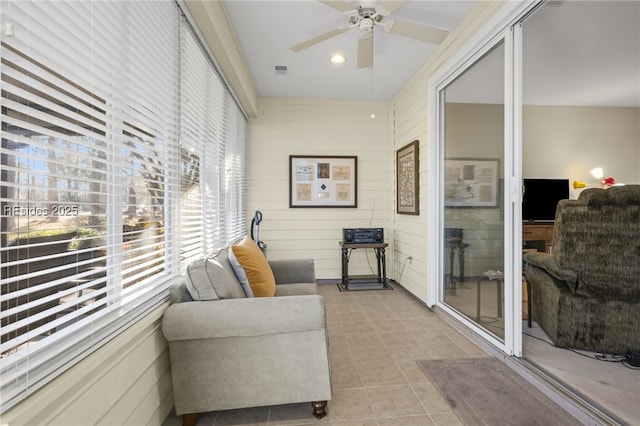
top-left (522, 179), bottom-right (569, 222)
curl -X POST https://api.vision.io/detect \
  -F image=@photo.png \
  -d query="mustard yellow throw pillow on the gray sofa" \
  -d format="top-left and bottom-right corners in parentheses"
top-left (229, 237), bottom-right (276, 297)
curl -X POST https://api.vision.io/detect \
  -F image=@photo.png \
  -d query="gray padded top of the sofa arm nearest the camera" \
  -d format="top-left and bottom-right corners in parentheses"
top-left (162, 295), bottom-right (326, 341)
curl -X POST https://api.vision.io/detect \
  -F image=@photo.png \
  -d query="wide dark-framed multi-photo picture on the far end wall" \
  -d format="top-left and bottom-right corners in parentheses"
top-left (289, 155), bottom-right (358, 207)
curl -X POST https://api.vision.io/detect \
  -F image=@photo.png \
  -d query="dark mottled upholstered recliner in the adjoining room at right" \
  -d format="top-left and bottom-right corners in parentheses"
top-left (524, 185), bottom-right (640, 354)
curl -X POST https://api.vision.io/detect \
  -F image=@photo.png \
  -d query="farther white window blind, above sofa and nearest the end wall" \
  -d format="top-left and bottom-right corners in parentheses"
top-left (180, 25), bottom-right (246, 261)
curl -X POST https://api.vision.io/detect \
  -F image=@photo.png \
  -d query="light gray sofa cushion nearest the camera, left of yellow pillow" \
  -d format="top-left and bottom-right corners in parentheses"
top-left (185, 250), bottom-right (245, 300)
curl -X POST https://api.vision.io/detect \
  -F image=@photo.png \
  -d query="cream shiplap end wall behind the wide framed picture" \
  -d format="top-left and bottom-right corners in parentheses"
top-left (247, 98), bottom-right (394, 279)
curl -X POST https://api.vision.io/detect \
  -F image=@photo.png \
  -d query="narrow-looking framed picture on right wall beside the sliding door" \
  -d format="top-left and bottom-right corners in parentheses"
top-left (396, 140), bottom-right (420, 215)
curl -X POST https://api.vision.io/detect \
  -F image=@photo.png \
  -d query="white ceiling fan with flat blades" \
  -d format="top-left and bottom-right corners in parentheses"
top-left (289, 0), bottom-right (448, 68)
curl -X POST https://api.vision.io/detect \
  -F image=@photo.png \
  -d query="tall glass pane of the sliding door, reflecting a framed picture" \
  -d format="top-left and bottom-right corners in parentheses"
top-left (440, 41), bottom-right (505, 340)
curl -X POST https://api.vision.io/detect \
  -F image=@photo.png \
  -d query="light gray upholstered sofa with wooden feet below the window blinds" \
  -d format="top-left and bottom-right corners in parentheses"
top-left (162, 249), bottom-right (331, 424)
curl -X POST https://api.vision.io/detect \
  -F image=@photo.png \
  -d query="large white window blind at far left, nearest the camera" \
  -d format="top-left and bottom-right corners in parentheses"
top-left (0, 1), bottom-right (180, 410)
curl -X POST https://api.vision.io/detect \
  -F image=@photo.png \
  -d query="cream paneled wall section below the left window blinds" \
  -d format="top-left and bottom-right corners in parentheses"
top-left (0, 305), bottom-right (173, 426)
